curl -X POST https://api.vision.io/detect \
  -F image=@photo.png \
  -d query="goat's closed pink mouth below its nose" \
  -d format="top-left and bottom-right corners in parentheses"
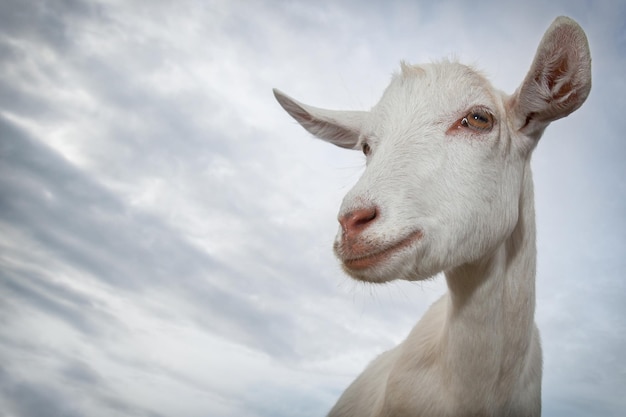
top-left (335, 230), bottom-right (422, 271)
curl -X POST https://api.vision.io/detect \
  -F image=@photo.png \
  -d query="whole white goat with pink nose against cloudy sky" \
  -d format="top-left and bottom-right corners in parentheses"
top-left (274, 17), bottom-right (591, 417)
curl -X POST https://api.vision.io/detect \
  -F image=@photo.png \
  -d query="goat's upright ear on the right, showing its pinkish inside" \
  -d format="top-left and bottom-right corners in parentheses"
top-left (509, 16), bottom-right (591, 139)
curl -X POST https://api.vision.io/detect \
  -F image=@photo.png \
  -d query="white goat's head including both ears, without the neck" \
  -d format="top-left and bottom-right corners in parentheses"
top-left (274, 17), bottom-right (591, 282)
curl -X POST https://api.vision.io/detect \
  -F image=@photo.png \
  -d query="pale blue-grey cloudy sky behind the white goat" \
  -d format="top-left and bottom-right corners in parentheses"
top-left (0, 0), bottom-right (626, 417)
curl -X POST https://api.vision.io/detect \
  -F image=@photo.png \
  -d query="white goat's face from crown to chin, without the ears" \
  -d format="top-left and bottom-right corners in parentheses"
top-left (334, 63), bottom-right (534, 282)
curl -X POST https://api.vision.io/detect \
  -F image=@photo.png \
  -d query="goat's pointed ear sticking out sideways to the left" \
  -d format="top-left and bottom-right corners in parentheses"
top-left (274, 89), bottom-right (368, 149)
